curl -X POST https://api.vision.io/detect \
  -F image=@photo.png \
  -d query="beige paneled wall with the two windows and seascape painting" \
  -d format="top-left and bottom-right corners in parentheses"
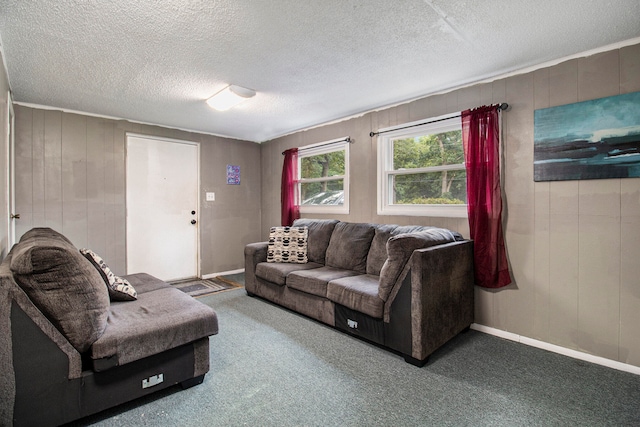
top-left (262, 45), bottom-right (640, 366)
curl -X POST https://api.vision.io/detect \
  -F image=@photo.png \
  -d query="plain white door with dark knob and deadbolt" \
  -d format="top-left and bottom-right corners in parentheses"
top-left (126, 135), bottom-right (199, 281)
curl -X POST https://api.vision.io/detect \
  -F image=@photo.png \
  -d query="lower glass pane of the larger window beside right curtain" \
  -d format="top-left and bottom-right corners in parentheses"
top-left (390, 170), bottom-right (467, 205)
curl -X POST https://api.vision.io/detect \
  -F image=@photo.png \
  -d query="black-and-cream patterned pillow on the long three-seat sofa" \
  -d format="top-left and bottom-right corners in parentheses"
top-left (267, 227), bottom-right (309, 264)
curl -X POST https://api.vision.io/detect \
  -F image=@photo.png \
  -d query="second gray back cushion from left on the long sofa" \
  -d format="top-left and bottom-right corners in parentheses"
top-left (326, 222), bottom-right (375, 274)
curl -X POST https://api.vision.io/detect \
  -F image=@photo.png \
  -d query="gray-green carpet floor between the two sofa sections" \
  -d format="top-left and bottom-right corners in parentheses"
top-left (73, 289), bottom-right (640, 426)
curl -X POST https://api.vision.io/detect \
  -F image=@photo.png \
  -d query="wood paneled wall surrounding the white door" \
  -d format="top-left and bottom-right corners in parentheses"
top-left (15, 106), bottom-right (260, 275)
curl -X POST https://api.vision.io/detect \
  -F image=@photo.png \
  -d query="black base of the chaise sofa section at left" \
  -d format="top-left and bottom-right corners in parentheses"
top-left (11, 303), bottom-right (209, 426)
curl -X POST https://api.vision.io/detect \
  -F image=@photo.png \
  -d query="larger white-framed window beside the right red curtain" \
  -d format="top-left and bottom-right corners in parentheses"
top-left (378, 115), bottom-right (467, 217)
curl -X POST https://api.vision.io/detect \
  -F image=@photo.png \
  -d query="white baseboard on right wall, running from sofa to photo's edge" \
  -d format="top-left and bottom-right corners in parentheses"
top-left (471, 323), bottom-right (640, 375)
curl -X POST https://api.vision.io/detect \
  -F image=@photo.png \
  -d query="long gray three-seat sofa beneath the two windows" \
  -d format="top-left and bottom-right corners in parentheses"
top-left (245, 219), bottom-right (474, 366)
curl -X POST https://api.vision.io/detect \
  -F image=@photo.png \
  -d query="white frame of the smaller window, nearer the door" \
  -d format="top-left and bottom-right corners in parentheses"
top-left (296, 137), bottom-right (351, 214)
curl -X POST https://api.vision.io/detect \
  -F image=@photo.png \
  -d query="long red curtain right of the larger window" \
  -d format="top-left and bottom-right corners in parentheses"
top-left (462, 105), bottom-right (511, 288)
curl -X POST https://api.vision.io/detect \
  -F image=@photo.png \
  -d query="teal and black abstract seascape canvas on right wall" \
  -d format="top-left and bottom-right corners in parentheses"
top-left (533, 92), bottom-right (640, 181)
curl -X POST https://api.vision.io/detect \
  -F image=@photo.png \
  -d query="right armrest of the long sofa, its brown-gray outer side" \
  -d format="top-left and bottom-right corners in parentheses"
top-left (409, 240), bottom-right (474, 360)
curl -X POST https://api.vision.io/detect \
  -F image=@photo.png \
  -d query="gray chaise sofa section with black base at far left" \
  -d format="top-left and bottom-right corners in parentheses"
top-left (0, 228), bottom-right (218, 426)
